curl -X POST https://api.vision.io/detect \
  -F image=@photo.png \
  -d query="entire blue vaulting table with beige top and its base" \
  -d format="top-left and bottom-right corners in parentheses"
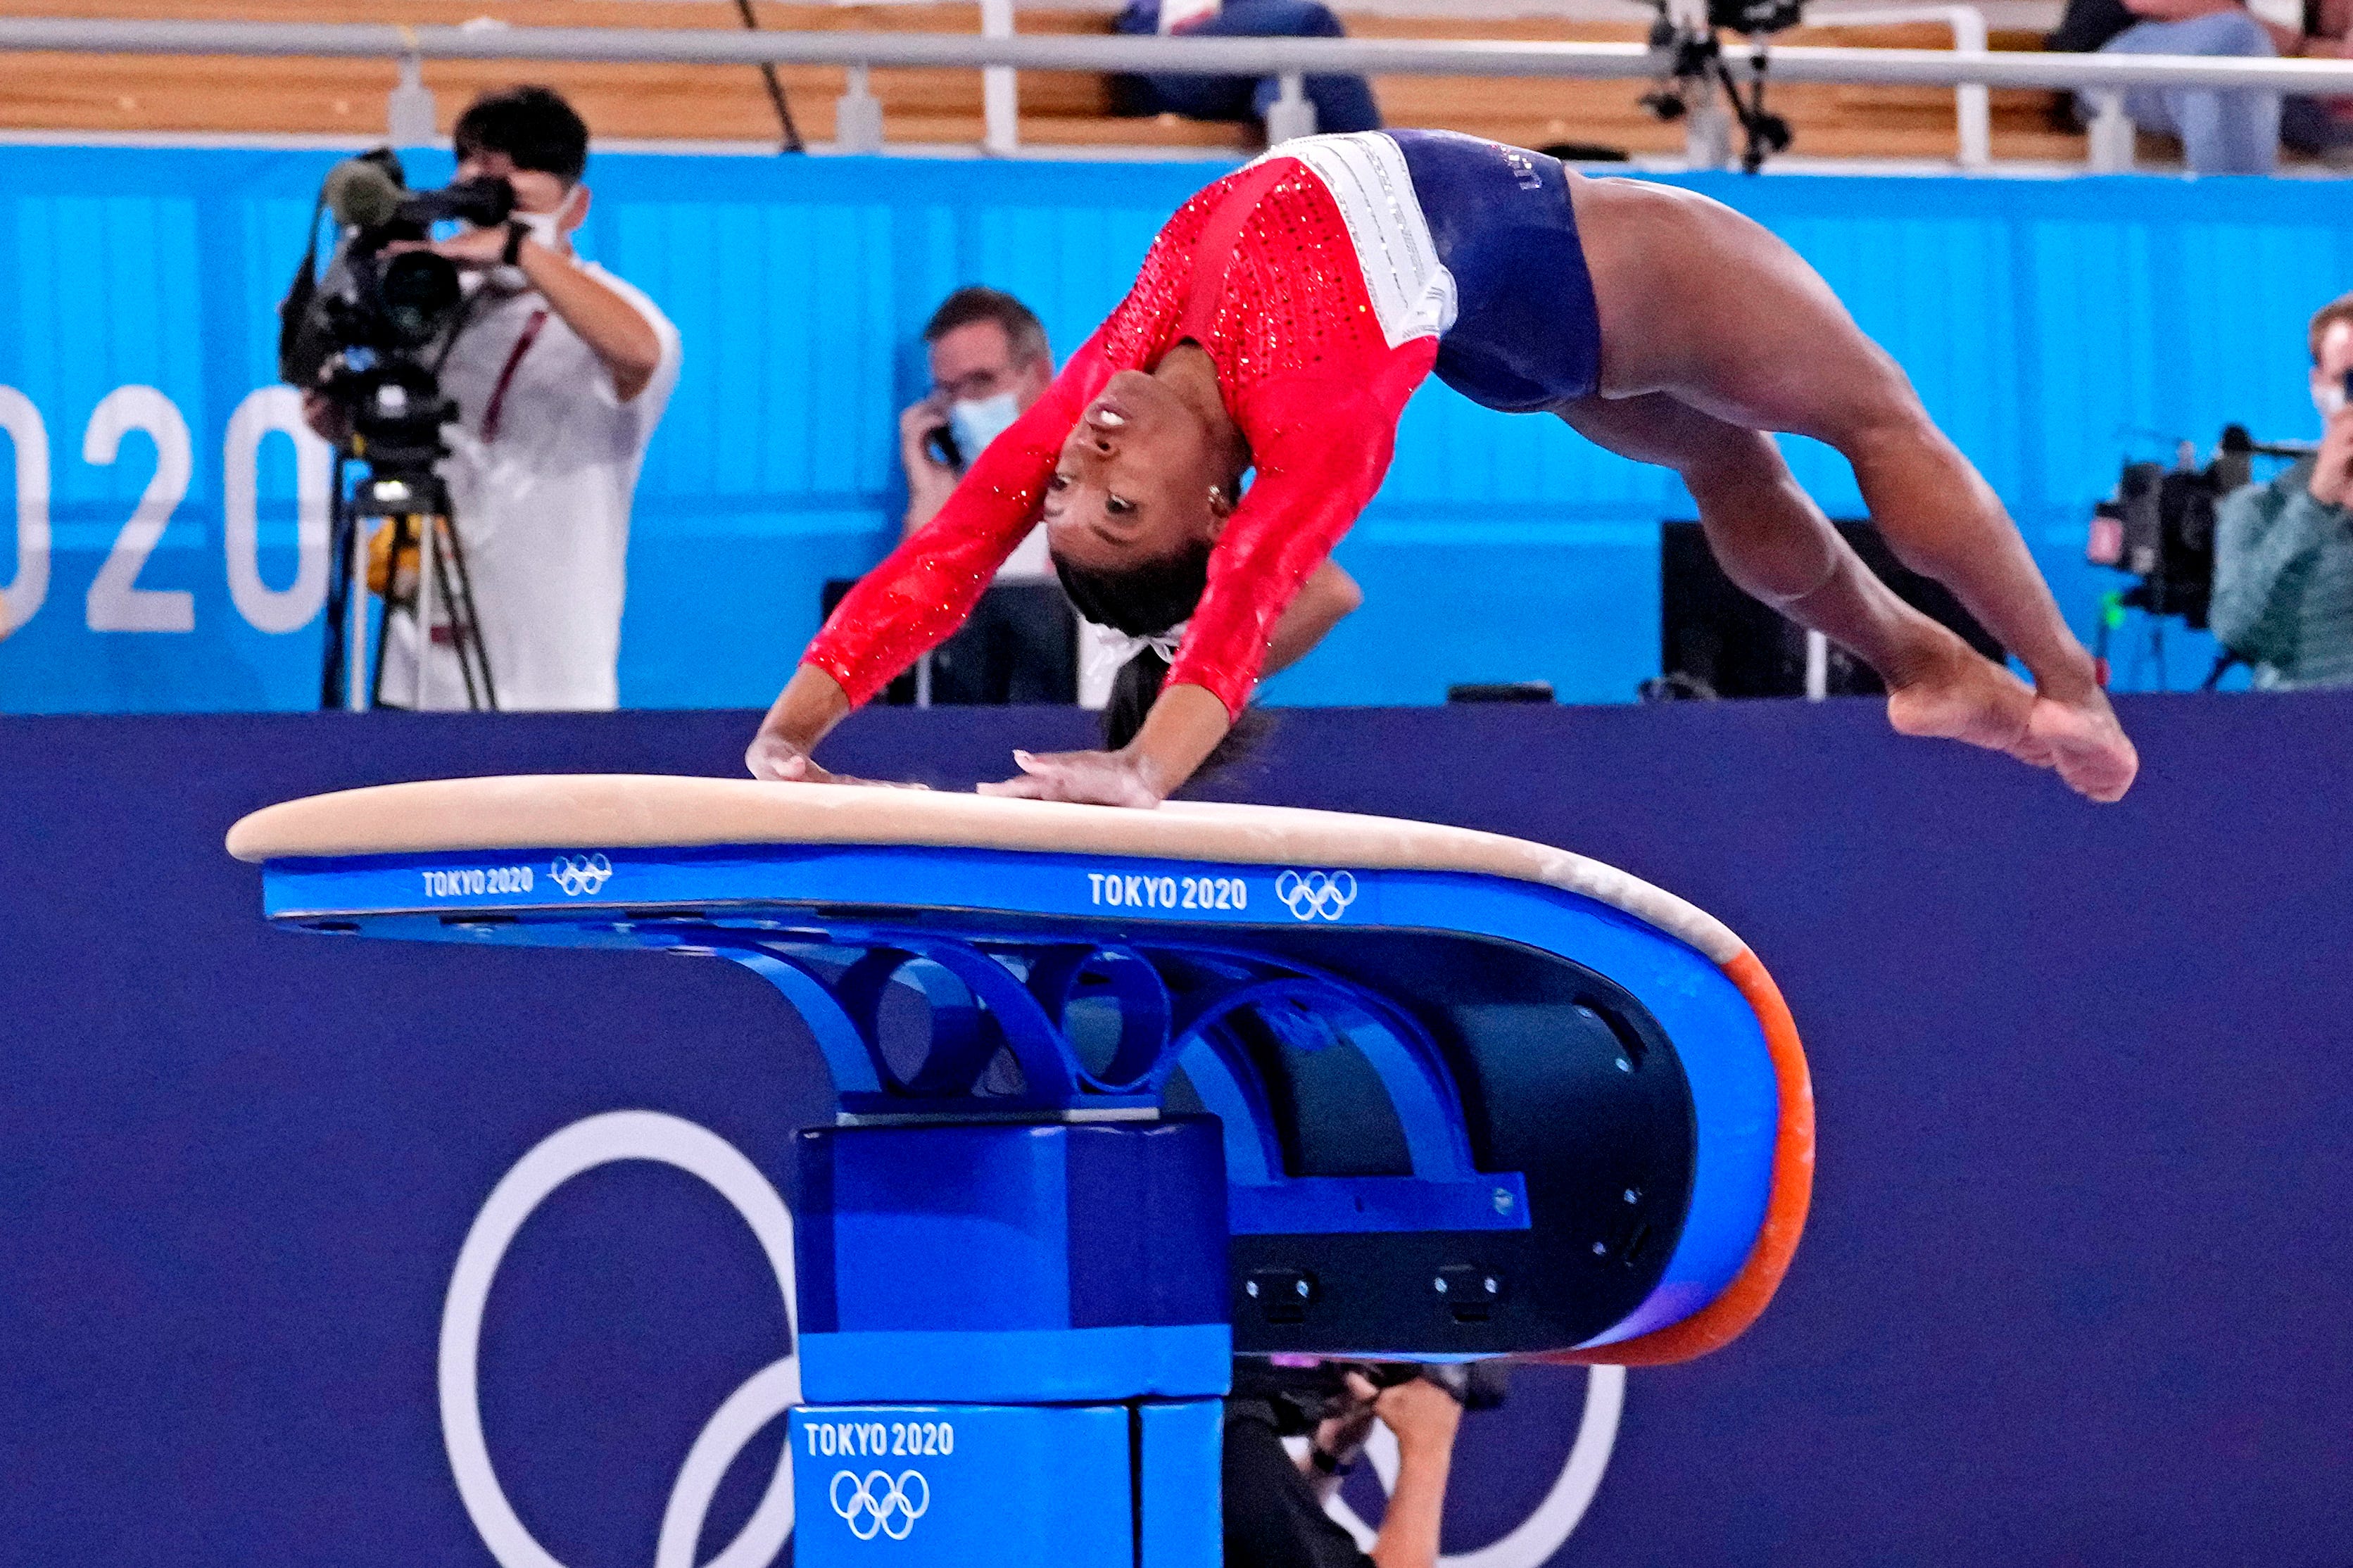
top-left (228, 775), bottom-right (1814, 1568)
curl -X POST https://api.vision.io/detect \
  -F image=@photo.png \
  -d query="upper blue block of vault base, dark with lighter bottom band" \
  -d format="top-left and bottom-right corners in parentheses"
top-left (795, 1116), bottom-right (1233, 1405)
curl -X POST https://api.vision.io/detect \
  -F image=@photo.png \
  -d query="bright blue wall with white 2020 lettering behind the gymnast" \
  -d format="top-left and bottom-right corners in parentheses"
top-left (0, 146), bottom-right (2353, 711)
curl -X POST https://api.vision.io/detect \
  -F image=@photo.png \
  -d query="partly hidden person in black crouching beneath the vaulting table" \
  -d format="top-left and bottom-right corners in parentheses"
top-left (1223, 1368), bottom-right (1463, 1568)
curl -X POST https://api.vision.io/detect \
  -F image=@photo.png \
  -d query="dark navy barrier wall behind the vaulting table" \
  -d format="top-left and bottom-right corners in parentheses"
top-left (0, 695), bottom-right (2353, 1568)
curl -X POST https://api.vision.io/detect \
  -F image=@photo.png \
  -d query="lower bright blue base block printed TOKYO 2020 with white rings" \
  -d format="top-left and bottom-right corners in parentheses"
top-left (788, 1398), bottom-right (1223, 1568)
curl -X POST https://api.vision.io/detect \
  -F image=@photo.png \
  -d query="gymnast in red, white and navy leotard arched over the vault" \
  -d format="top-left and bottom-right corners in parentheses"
top-left (746, 132), bottom-right (2139, 805)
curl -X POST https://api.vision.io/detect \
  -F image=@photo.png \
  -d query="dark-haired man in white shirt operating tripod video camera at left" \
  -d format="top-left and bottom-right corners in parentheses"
top-left (303, 87), bottom-right (678, 709)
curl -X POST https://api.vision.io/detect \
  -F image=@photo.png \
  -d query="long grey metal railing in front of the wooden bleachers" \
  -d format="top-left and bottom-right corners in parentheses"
top-left (0, 14), bottom-right (2353, 167)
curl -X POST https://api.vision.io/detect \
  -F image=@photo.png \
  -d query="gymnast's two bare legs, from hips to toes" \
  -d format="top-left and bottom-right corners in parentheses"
top-left (1560, 179), bottom-right (2139, 800)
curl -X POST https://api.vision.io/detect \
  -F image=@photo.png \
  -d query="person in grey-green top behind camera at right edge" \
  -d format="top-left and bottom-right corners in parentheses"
top-left (2209, 294), bottom-right (2353, 690)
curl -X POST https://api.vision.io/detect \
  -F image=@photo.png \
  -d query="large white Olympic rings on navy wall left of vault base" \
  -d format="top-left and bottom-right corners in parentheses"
top-left (440, 1111), bottom-right (800, 1568)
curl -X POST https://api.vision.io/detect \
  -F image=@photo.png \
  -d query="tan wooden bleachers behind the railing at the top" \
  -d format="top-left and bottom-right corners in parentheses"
top-left (0, 0), bottom-right (2085, 163)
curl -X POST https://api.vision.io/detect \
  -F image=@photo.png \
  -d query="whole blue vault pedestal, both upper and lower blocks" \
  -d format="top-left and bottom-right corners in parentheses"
top-left (790, 1116), bottom-right (1233, 1568)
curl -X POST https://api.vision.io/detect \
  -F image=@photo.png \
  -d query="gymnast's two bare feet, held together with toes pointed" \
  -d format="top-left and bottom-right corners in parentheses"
top-left (1887, 633), bottom-right (2141, 800)
